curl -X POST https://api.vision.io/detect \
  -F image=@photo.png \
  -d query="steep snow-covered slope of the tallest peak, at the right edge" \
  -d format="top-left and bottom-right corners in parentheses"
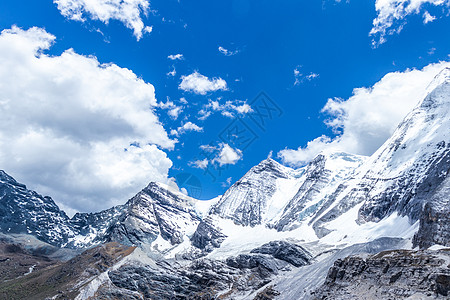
top-left (312, 69), bottom-right (450, 244)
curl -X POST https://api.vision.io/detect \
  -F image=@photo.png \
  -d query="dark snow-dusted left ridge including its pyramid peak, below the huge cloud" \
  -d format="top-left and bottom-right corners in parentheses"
top-left (0, 171), bottom-right (200, 249)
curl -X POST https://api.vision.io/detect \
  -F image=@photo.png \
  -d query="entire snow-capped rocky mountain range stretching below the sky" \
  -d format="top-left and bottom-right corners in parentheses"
top-left (0, 68), bottom-right (450, 299)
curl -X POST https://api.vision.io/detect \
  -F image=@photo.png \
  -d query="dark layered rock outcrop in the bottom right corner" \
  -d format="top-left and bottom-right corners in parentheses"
top-left (313, 249), bottom-right (450, 299)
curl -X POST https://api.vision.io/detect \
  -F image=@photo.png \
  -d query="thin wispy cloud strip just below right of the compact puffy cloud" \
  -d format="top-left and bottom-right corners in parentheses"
top-left (198, 100), bottom-right (253, 120)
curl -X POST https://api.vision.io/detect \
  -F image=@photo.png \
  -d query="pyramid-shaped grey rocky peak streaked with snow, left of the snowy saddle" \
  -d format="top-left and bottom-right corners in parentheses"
top-left (68, 182), bottom-right (211, 248)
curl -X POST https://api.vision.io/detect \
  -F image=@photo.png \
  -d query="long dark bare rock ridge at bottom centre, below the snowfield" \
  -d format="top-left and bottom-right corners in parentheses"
top-left (102, 242), bottom-right (311, 299)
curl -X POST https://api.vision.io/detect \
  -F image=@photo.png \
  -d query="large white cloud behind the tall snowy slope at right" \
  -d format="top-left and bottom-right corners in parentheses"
top-left (278, 62), bottom-right (450, 166)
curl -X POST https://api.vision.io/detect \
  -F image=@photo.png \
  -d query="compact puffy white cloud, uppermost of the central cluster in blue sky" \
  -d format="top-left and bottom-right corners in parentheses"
top-left (179, 72), bottom-right (227, 95)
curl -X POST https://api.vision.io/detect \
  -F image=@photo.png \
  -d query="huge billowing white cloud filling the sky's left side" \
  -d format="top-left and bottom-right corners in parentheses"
top-left (0, 27), bottom-right (174, 211)
